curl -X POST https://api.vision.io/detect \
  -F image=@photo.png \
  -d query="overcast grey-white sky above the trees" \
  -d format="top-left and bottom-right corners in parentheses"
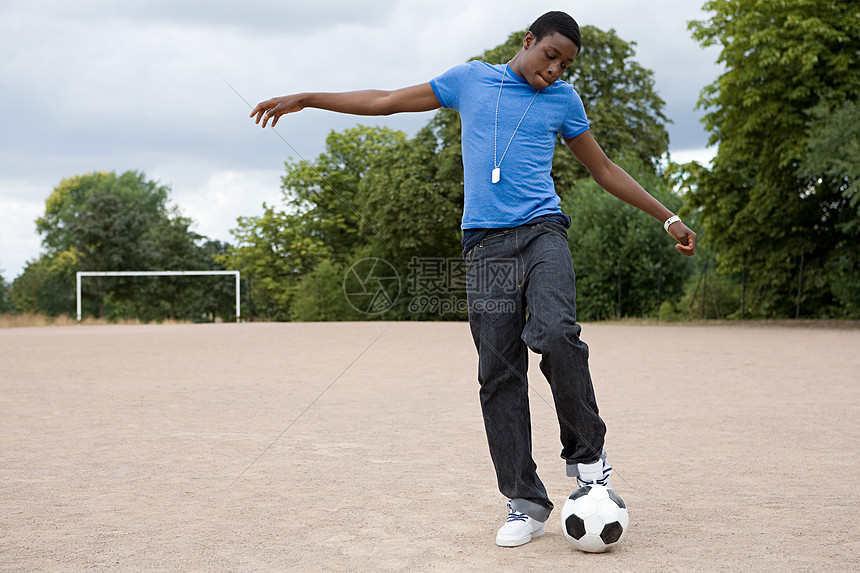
top-left (0, 0), bottom-right (719, 281)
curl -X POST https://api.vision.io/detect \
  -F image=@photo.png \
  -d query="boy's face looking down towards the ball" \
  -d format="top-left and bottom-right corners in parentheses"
top-left (513, 32), bottom-right (579, 90)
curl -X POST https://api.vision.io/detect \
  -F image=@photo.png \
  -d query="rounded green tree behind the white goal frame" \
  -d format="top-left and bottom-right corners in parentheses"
top-left (19, 171), bottom-right (234, 320)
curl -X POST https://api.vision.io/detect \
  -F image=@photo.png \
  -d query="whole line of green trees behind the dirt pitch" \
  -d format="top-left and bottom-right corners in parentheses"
top-left (0, 0), bottom-right (860, 320)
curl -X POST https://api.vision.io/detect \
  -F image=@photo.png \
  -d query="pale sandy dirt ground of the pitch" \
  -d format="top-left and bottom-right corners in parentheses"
top-left (0, 322), bottom-right (860, 573)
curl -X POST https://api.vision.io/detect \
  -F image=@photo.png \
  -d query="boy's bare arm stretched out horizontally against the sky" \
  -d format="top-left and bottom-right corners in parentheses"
top-left (250, 83), bottom-right (442, 127)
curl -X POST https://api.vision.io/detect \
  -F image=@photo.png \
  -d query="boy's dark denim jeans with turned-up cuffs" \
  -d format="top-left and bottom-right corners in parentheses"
top-left (464, 222), bottom-right (606, 521)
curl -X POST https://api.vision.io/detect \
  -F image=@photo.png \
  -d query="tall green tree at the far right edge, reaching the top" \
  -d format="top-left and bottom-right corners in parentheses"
top-left (690, 0), bottom-right (860, 317)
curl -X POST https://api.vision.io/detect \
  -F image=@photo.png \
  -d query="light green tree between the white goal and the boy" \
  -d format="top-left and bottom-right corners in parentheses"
top-left (221, 126), bottom-right (414, 320)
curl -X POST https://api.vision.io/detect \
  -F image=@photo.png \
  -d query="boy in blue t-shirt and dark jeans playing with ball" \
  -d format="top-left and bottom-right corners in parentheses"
top-left (251, 12), bottom-right (696, 547)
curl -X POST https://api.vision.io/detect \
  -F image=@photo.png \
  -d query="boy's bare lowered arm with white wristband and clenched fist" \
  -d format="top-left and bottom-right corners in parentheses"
top-left (564, 131), bottom-right (696, 256)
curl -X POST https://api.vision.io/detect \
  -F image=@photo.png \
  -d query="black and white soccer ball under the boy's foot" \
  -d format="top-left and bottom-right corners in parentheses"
top-left (561, 485), bottom-right (629, 553)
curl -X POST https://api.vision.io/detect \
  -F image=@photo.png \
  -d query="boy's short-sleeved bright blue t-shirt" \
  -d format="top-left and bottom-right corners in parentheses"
top-left (430, 61), bottom-right (588, 229)
